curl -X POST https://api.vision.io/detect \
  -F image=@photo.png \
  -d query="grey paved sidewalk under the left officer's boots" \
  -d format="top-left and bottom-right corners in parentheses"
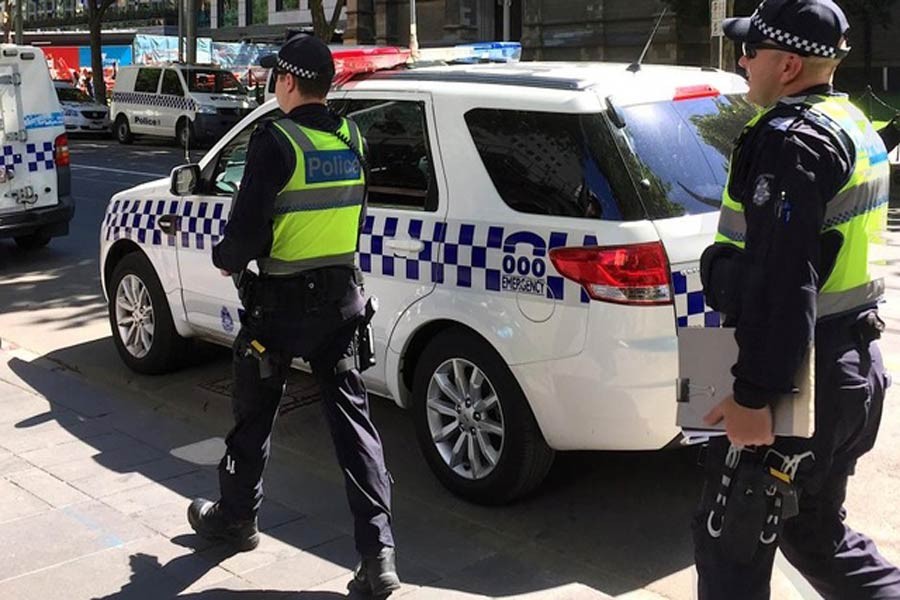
top-left (0, 349), bottom-right (620, 600)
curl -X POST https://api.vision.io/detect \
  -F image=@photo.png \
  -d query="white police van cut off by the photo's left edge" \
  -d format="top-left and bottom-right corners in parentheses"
top-left (0, 44), bottom-right (75, 249)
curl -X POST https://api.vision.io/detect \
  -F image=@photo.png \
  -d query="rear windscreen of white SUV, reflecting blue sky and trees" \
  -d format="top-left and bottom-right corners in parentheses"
top-left (621, 95), bottom-right (756, 219)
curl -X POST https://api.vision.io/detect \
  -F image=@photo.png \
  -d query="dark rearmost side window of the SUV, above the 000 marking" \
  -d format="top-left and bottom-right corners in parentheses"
top-left (465, 108), bottom-right (644, 221)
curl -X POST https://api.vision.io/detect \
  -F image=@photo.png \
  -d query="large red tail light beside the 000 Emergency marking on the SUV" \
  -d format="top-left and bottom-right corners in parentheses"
top-left (550, 242), bottom-right (672, 305)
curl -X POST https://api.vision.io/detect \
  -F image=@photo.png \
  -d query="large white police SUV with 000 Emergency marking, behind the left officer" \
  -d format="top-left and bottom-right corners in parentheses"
top-left (100, 63), bottom-right (754, 503)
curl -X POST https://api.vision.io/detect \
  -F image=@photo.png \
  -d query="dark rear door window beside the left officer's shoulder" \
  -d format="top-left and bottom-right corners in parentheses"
top-left (331, 99), bottom-right (437, 211)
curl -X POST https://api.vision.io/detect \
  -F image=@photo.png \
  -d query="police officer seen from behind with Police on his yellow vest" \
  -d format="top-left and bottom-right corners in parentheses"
top-left (188, 36), bottom-right (400, 597)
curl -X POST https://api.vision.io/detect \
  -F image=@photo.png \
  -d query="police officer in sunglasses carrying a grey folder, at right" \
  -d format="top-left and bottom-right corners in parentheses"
top-left (692, 0), bottom-right (900, 600)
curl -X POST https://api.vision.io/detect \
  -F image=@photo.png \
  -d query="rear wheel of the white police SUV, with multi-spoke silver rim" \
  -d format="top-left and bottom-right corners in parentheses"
top-left (413, 329), bottom-right (554, 504)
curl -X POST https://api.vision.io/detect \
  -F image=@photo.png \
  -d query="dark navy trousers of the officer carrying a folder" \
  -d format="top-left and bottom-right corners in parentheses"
top-left (692, 316), bottom-right (900, 600)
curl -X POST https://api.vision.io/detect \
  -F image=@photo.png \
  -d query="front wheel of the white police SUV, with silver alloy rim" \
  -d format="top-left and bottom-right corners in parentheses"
top-left (109, 252), bottom-right (190, 375)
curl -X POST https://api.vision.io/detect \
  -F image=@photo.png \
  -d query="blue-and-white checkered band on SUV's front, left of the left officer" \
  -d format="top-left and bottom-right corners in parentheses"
top-left (104, 200), bottom-right (225, 250)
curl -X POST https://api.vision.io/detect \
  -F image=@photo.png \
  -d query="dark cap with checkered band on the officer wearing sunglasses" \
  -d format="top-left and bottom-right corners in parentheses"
top-left (722, 0), bottom-right (850, 58)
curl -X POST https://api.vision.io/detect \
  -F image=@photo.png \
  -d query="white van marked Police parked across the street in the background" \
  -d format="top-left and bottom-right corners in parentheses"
top-left (110, 63), bottom-right (256, 146)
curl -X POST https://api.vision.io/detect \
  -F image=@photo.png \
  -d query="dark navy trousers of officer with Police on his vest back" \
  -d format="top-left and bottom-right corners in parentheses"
top-left (219, 276), bottom-right (394, 556)
